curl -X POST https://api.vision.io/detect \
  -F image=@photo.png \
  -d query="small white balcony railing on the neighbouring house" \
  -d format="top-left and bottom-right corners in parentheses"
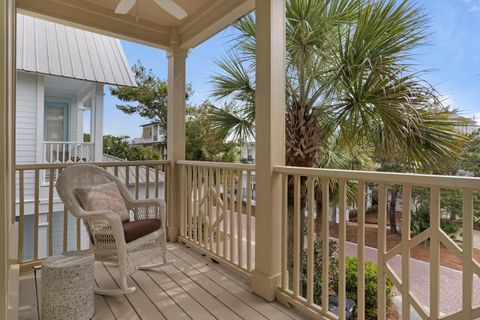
top-left (43, 141), bottom-right (95, 163)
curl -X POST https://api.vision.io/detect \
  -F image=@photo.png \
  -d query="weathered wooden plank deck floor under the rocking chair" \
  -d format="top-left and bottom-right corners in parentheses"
top-left (20, 243), bottom-right (303, 320)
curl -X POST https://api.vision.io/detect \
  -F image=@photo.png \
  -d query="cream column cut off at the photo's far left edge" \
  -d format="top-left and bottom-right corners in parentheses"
top-left (0, 0), bottom-right (18, 319)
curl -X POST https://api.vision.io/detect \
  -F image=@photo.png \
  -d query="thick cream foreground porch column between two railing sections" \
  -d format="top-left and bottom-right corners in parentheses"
top-left (252, 0), bottom-right (285, 301)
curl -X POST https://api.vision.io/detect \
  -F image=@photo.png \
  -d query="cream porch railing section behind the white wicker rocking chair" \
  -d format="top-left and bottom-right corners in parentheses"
top-left (13, 161), bottom-right (170, 271)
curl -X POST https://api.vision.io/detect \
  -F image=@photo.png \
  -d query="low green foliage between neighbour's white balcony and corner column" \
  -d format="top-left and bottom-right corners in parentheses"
top-left (103, 135), bottom-right (161, 161)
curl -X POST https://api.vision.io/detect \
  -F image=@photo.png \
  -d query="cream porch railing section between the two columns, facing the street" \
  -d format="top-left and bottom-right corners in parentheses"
top-left (178, 161), bottom-right (255, 276)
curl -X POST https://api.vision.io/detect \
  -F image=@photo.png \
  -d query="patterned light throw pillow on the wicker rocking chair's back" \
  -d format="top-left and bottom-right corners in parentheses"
top-left (75, 182), bottom-right (130, 221)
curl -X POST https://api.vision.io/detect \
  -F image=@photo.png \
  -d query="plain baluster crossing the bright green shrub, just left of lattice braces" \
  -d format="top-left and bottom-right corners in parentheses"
top-left (357, 181), bottom-right (366, 320)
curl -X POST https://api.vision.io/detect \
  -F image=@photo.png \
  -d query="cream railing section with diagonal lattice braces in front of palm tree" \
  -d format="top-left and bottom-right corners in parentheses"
top-left (275, 166), bottom-right (480, 320)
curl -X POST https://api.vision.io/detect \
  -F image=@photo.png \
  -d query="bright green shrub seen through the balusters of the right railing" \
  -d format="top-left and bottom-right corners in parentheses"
top-left (333, 257), bottom-right (393, 319)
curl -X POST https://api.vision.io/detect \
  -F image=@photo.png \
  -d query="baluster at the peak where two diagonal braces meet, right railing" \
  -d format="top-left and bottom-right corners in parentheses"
top-left (430, 187), bottom-right (440, 320)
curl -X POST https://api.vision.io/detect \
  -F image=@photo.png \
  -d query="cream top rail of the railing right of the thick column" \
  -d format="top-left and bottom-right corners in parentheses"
top-left (274, 166), bottom-right (480, 190)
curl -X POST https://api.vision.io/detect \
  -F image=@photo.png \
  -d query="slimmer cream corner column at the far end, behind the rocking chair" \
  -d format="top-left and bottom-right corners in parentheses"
top-left (165, 44), bottom-right (187, 242)
